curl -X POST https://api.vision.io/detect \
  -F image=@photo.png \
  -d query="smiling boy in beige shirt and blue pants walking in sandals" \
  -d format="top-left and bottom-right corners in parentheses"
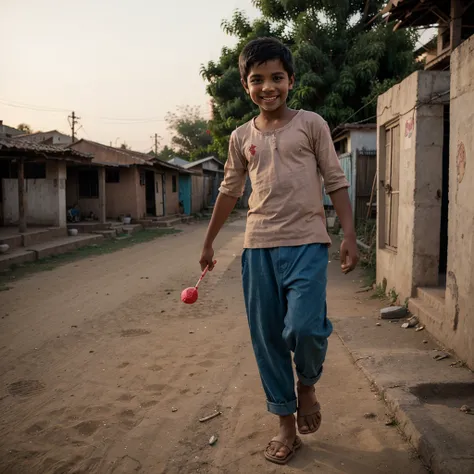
top-left (200, 38), bottom-right (357, 464)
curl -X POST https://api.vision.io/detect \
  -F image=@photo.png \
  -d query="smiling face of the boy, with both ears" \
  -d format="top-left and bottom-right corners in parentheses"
top-left (242, 59), bottom-right (295, 112)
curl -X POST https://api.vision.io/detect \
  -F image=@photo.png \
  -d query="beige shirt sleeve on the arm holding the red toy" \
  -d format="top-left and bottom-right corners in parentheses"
top-left (219, 131), bottom-right (247, 198)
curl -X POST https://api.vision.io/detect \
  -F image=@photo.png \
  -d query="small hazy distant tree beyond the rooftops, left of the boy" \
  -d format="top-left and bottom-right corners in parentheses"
top-left (166, 106), bottom-right (212, 161)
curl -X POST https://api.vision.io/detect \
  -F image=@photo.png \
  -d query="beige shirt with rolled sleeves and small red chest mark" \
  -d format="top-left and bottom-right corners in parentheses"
top-left (219, 110), bottom-right (349, 248)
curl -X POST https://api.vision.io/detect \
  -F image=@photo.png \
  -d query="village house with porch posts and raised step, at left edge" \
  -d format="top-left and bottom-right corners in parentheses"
top-left (0, 138), bottom-right (102, 271)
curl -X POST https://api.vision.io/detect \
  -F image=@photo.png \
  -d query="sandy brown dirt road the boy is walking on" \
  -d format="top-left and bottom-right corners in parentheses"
top-left (0, 221), bottom-right (426, 474)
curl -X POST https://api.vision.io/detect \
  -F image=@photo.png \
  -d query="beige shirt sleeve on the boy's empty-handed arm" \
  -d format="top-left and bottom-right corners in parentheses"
top-left (313, 119), bottom-right (350, 194)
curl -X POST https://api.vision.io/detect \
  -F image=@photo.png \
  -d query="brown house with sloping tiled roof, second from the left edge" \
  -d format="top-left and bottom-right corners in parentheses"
top-left (66, 140), bottom-right (192, 222)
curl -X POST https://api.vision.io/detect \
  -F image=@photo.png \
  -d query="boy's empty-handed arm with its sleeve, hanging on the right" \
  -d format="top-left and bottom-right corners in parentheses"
top-left (316, 118), bottom-right (359, 273)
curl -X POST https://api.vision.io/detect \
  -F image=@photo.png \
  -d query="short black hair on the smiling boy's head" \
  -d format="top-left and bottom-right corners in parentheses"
top-left (239, 37), bottom-right (295, 81)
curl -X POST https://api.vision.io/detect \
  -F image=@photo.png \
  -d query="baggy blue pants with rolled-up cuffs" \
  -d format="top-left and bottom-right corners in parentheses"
top-left (242, 244), bottom-right (332, 416)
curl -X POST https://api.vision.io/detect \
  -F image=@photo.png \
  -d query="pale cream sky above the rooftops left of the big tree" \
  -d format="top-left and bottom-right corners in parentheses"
top-left (0, 0), bottom-right (258, 152)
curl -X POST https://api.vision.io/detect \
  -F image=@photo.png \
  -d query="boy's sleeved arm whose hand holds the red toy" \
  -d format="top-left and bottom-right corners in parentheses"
top-left (199, 132), bottom-right (247, 270)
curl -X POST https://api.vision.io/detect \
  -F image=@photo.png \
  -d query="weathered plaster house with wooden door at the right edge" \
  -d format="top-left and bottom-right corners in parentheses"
top-left (377, 0), bottom-right (474, 369)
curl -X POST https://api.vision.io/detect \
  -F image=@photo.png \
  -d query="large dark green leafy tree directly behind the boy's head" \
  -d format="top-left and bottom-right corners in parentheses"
top-left (201, 0), bottom-right (417, 158)
